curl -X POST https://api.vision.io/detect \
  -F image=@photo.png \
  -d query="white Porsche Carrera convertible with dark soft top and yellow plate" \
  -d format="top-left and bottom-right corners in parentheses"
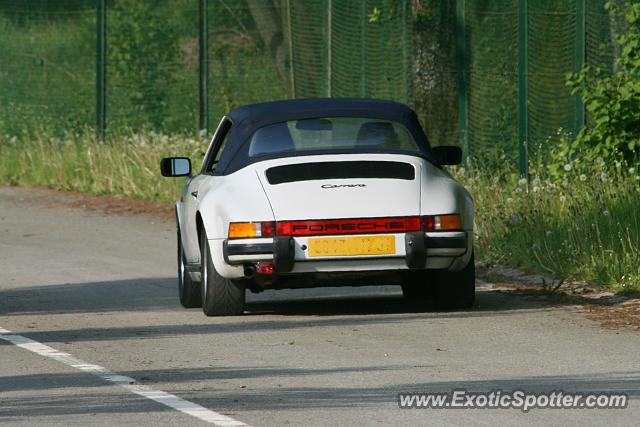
top-left (160, 99), bottom-right (475, 316)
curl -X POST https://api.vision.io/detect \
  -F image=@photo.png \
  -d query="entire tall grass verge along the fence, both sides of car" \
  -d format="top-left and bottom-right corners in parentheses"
top-left (0, 132), bottom-right (640, 292)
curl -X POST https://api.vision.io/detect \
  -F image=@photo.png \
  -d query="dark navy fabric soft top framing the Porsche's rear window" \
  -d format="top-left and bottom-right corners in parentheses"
top-left (216, 98), bottom-right (436, 175)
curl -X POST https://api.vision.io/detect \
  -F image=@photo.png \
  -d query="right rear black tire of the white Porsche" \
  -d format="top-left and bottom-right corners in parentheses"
top-left (433, 253), bottom-right (476, 310)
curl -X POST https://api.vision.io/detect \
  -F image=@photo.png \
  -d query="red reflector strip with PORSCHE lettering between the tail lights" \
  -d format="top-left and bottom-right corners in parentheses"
top-left (276, 216), bottom-right (421, 236)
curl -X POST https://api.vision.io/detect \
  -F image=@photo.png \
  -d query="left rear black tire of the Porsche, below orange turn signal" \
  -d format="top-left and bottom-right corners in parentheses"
top-left (200, 230), bottom-right (245, 316)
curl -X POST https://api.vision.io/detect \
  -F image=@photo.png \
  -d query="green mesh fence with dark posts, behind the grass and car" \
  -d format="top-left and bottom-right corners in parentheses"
top-left (0, 0), bottom-right (622, 172)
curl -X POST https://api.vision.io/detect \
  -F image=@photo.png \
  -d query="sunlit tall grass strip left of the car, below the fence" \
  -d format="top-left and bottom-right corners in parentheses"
top-left (0, 131), bottom-right (207, 201)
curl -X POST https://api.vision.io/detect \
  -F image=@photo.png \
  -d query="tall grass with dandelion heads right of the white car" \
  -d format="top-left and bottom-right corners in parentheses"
top-left (456, 160), bottom-right (640, 292)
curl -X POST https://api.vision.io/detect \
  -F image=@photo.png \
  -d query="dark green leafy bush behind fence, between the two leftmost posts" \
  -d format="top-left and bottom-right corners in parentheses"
top-left (108, 0), bottom-right (178, 129)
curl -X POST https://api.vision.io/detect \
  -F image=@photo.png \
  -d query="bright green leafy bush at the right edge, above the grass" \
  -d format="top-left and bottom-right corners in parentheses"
top-left (560, 2), bottom-right (640, 164)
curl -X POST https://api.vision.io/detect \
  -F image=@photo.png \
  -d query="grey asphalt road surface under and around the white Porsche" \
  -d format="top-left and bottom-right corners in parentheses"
top-left (0, 187), bottom-right (640, 426)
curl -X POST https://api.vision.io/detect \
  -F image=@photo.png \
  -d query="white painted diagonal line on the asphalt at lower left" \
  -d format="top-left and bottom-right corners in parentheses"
top-left (0, 327), bottom-right (250, 427)
